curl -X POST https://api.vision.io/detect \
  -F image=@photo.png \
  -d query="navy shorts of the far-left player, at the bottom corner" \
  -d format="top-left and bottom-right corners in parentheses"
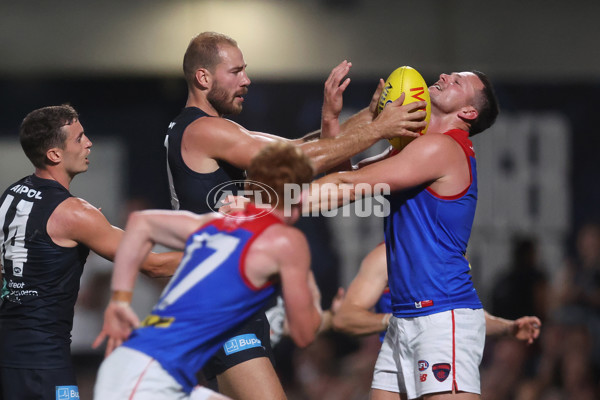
top-left (0, 367), bottom-right (79, 400)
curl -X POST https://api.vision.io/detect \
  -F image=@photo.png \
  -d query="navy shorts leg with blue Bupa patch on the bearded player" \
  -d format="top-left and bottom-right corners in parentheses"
top-left (202, 311), bottom-right (274, 380)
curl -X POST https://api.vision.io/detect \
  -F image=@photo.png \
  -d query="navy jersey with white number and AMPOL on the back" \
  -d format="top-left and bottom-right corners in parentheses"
top-left (0, 175), bottom-right (89, 369)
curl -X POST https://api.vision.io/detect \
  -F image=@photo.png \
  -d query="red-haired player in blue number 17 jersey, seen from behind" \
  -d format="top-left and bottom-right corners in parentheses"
top-left (95, 143), bottom-right (321, 400)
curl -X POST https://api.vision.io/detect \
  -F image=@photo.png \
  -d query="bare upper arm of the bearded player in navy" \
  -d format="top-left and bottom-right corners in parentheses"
top-left (182, 118), bottom-right (280, 169)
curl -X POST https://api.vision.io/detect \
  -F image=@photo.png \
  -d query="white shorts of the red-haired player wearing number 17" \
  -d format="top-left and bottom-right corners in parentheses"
top-left (94, 346), bottom-right (221, 400)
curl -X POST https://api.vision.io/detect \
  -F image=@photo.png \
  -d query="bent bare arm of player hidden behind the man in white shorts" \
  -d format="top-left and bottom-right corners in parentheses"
top-left (333, 243), bottom-right (391, 335)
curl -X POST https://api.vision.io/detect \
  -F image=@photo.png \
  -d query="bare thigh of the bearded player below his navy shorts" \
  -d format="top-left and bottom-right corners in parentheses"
top-left (217, 357), bottom-right (286, 400)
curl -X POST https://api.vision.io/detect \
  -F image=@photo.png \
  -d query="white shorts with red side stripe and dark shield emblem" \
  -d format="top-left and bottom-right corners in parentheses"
top-left (371, 309), bottom-right (485, 399)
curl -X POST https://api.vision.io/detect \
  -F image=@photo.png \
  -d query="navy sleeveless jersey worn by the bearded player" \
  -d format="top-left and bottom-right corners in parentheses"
top-left (165, 107), bottom-right (244, 214)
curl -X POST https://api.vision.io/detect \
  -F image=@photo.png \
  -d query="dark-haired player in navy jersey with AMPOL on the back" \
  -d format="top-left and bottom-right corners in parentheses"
top-left (0, 105), bottom-right (180, 400)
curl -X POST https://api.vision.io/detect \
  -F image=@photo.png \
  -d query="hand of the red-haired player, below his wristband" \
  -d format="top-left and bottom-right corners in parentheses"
top-left (92, 301), bottom-right (140, 357)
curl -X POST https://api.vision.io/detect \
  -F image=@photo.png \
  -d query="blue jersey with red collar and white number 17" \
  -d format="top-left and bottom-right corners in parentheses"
top-left (123, 205), bottom-right (282, 392)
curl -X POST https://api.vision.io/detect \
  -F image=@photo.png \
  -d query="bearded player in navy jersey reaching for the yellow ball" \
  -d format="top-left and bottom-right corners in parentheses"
top-left (165, 32), bottom-right (425, 400)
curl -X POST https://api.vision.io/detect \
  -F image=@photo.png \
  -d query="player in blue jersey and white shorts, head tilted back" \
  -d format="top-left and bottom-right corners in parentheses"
top-left (312, 71), bottom-right (498, 400)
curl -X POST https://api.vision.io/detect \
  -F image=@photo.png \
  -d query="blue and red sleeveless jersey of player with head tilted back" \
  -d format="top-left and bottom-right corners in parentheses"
top-left (384, 129), bottom-right (482, 318)
